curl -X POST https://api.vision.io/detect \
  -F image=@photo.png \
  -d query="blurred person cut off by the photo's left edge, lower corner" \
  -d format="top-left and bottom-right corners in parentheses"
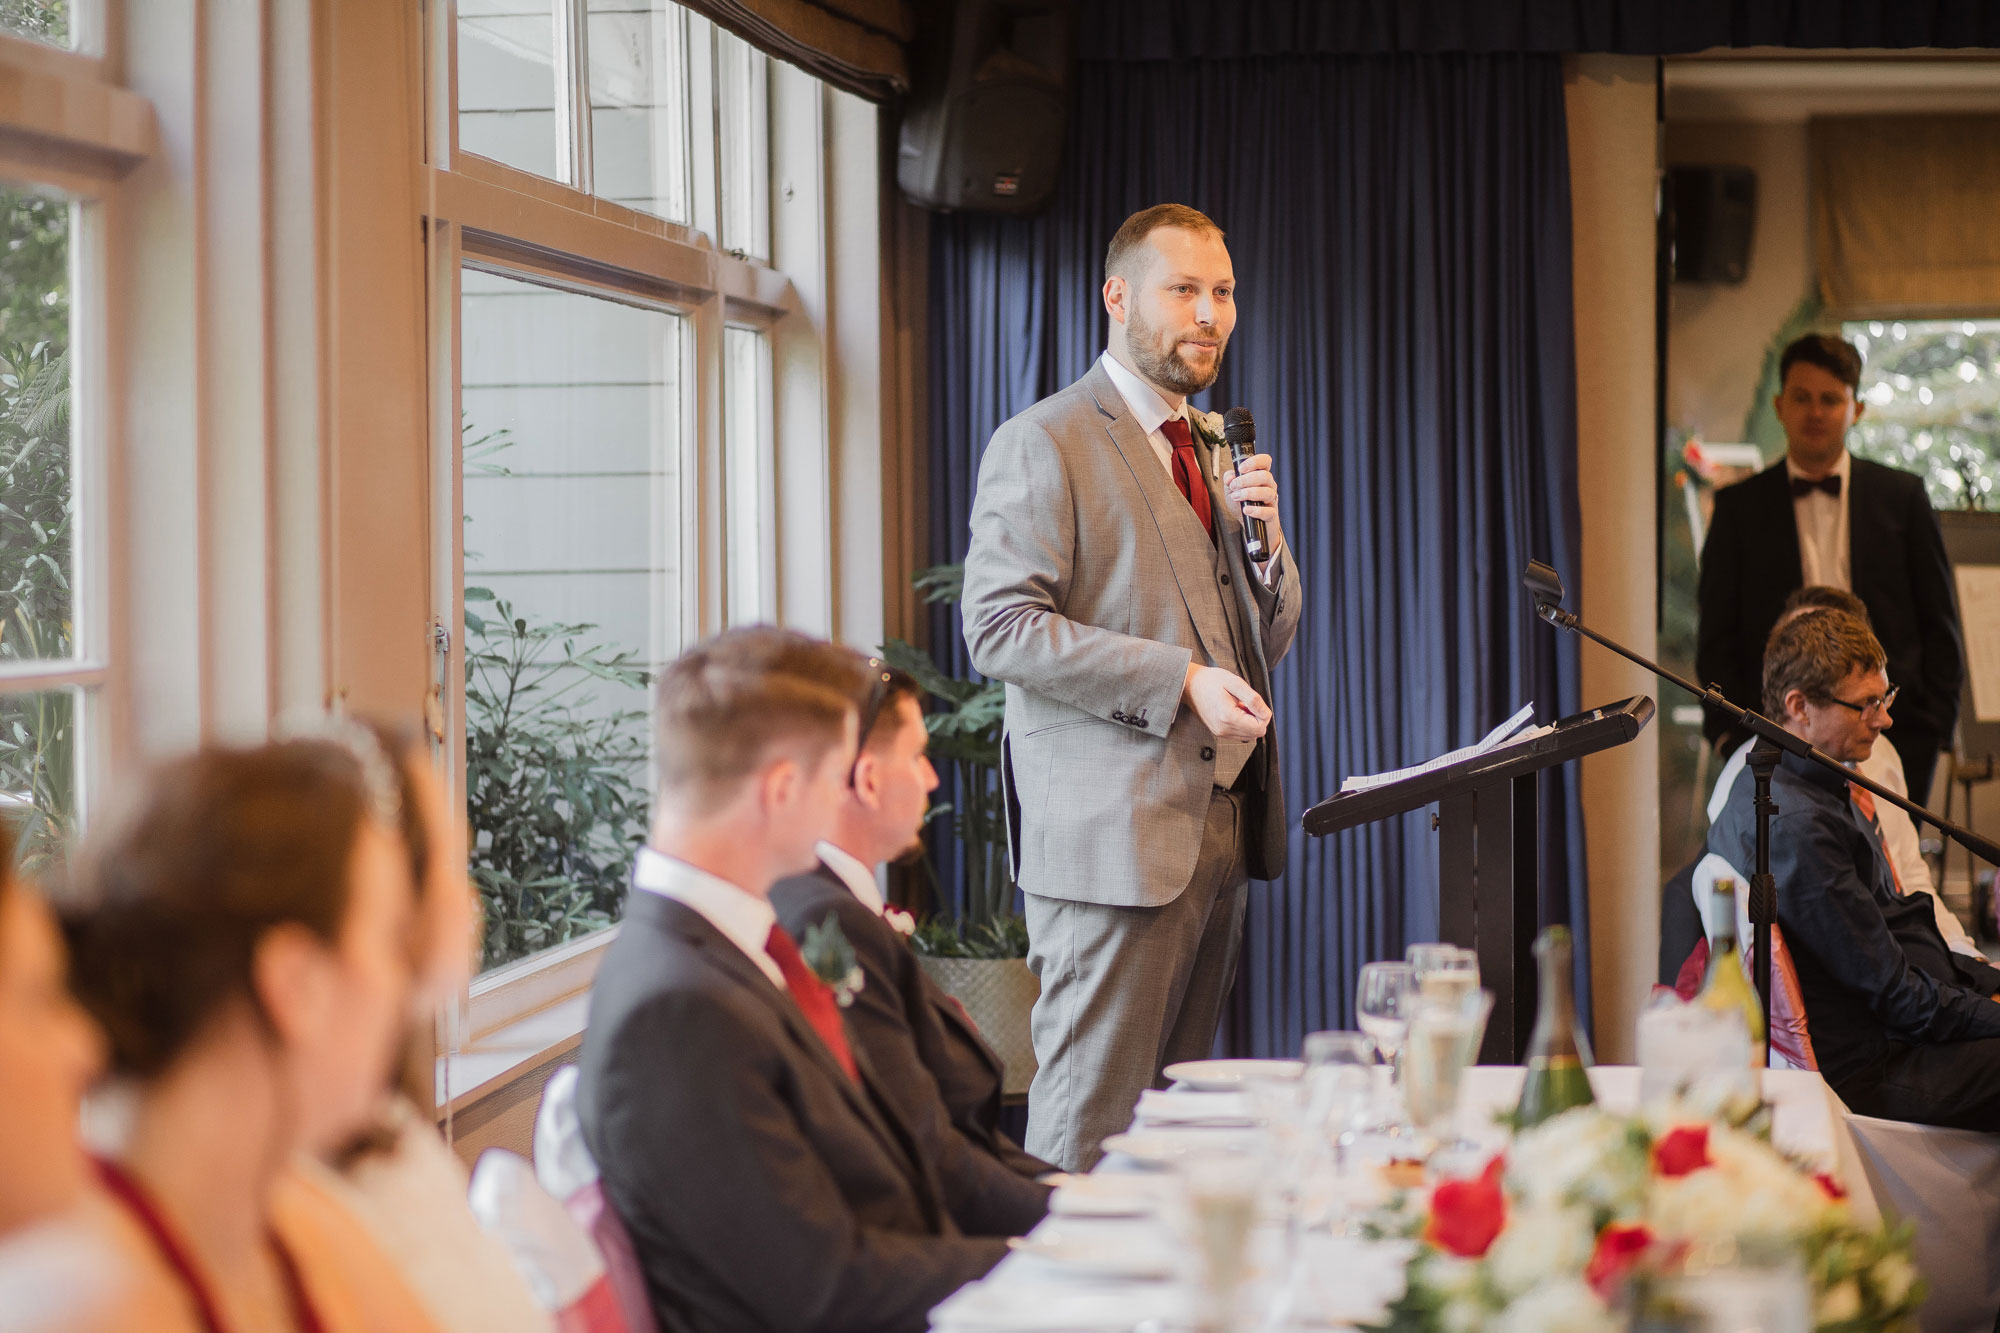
top-left (0, 827), bottom-right (110, 1329)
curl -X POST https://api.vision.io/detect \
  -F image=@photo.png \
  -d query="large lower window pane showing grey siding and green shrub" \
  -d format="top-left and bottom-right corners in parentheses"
top-left (462, 270), bottom-right (688, 967)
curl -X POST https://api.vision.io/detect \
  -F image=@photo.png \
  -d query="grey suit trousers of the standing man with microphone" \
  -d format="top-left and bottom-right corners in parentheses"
top-left (1026, 789), bottom-right (1250, 1171)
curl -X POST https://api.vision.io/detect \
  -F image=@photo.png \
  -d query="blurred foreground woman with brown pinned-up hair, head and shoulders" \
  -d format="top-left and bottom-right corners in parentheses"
top-left (66, 729), bottom-right (434, 1333)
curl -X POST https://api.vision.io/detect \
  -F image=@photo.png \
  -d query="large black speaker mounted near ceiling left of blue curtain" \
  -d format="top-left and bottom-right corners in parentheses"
top-left (896, 0), bottom-right (1076, 212)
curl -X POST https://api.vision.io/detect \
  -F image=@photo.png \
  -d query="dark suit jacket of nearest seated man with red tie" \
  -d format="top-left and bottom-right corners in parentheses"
top-left (576, 891), bottom-right (1006, 1333)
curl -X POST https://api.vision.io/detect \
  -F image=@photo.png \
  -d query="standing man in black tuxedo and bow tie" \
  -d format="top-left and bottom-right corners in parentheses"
top-left (1694, 334), bottom-right (1966, 801)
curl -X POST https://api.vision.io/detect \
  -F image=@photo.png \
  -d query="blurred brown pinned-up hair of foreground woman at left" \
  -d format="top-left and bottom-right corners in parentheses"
top-left (62, 733), bottom-right (408, 1079)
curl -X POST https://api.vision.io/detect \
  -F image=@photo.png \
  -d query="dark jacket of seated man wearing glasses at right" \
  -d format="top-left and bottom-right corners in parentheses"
top-left (1708, 755), bottom-right (2000, 1097)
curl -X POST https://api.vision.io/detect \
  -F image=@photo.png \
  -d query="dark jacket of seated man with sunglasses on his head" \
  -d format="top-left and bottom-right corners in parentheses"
top-left (770, 865), bottom-right (1054, 1235)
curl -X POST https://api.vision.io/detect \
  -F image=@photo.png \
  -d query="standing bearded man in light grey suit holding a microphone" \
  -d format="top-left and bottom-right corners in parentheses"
top-left (964, 204), bottom-right (1300, 1169)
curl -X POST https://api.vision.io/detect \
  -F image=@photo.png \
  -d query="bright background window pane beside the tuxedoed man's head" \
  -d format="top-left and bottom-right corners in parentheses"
top-left (1840, 318), bottom-right (2000, 508)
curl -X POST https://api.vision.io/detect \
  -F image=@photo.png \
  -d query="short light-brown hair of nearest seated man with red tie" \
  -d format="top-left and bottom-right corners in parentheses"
top-left (654, 624), bottom-right (868, 813)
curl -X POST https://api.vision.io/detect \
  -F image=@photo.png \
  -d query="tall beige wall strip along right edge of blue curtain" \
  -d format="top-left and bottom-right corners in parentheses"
top-left (1564, 56), bottom-right (1660, 1061)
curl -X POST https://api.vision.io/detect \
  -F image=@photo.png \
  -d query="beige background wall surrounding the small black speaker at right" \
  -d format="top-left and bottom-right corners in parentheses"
top-left (1666, 118), bottom-right (1812, 442)
